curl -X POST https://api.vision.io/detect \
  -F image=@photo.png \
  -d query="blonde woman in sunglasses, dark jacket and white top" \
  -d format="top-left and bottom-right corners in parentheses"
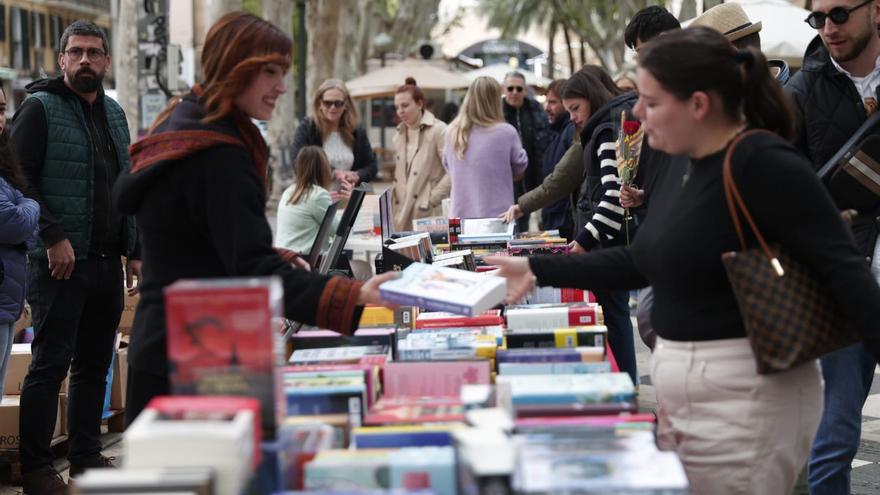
top-left (291, 79), bottom-right (378, 200)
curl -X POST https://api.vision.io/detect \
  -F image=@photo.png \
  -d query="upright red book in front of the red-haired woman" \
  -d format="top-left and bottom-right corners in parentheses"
top-left (165, 278), bottom-right (285, 439)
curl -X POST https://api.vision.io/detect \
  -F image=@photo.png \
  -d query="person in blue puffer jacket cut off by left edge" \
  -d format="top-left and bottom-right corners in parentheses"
top-left (0, 88), bottom-right (40, 397)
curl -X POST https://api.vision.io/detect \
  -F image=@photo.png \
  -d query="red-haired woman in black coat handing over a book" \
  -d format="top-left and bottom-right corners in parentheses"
top-left (114, 12), bottom-right (394, 423)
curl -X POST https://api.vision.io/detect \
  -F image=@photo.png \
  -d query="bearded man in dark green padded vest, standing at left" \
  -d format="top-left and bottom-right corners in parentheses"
top-left (11, 21), bottom-right (140, 494)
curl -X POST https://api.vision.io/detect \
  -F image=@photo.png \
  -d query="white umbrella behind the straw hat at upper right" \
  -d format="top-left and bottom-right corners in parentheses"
top-left (685, 0), bottom-right (817, 67)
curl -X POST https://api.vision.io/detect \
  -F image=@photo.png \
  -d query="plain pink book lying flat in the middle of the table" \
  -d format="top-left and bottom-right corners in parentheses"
top-left (384, 360), bottom-right (491, 398)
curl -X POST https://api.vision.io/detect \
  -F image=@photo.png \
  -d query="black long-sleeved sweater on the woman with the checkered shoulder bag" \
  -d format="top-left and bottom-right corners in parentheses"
top-left (530, 134), bottom-right (880, 354)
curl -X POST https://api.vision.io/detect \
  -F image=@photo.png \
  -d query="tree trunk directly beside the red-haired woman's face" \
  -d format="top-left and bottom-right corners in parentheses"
top-left (262, 0), bottom-right (296, 199)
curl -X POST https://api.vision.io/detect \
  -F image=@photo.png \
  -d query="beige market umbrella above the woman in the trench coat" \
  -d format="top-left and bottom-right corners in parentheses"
top-left (345, 59), bottom-right (470, 99)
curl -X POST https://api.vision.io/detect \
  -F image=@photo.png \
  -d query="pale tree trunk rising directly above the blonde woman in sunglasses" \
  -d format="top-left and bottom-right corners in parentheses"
top-left (306, 0), bottom-right (344, 101)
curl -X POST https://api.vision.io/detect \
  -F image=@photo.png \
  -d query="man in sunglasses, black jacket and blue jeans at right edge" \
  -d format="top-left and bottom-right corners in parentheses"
top-left (785, 0), bottom-right (880, 495)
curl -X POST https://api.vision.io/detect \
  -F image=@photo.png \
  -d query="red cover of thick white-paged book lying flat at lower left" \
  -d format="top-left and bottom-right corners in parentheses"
top-left (147, 395), bottom-right (263, 469)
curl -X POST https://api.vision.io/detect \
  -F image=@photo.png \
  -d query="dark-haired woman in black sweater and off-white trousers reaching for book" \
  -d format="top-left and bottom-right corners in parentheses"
top-left (489, 27), bottom-right (880, 494)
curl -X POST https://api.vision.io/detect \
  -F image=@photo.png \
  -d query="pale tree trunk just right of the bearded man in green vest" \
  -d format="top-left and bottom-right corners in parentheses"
top-left (113, 0), bottom-right (140, 142)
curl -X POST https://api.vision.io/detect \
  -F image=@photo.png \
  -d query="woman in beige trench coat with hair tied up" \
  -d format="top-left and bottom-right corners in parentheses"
top-left (392, 77), bottom-right (451, 231)
